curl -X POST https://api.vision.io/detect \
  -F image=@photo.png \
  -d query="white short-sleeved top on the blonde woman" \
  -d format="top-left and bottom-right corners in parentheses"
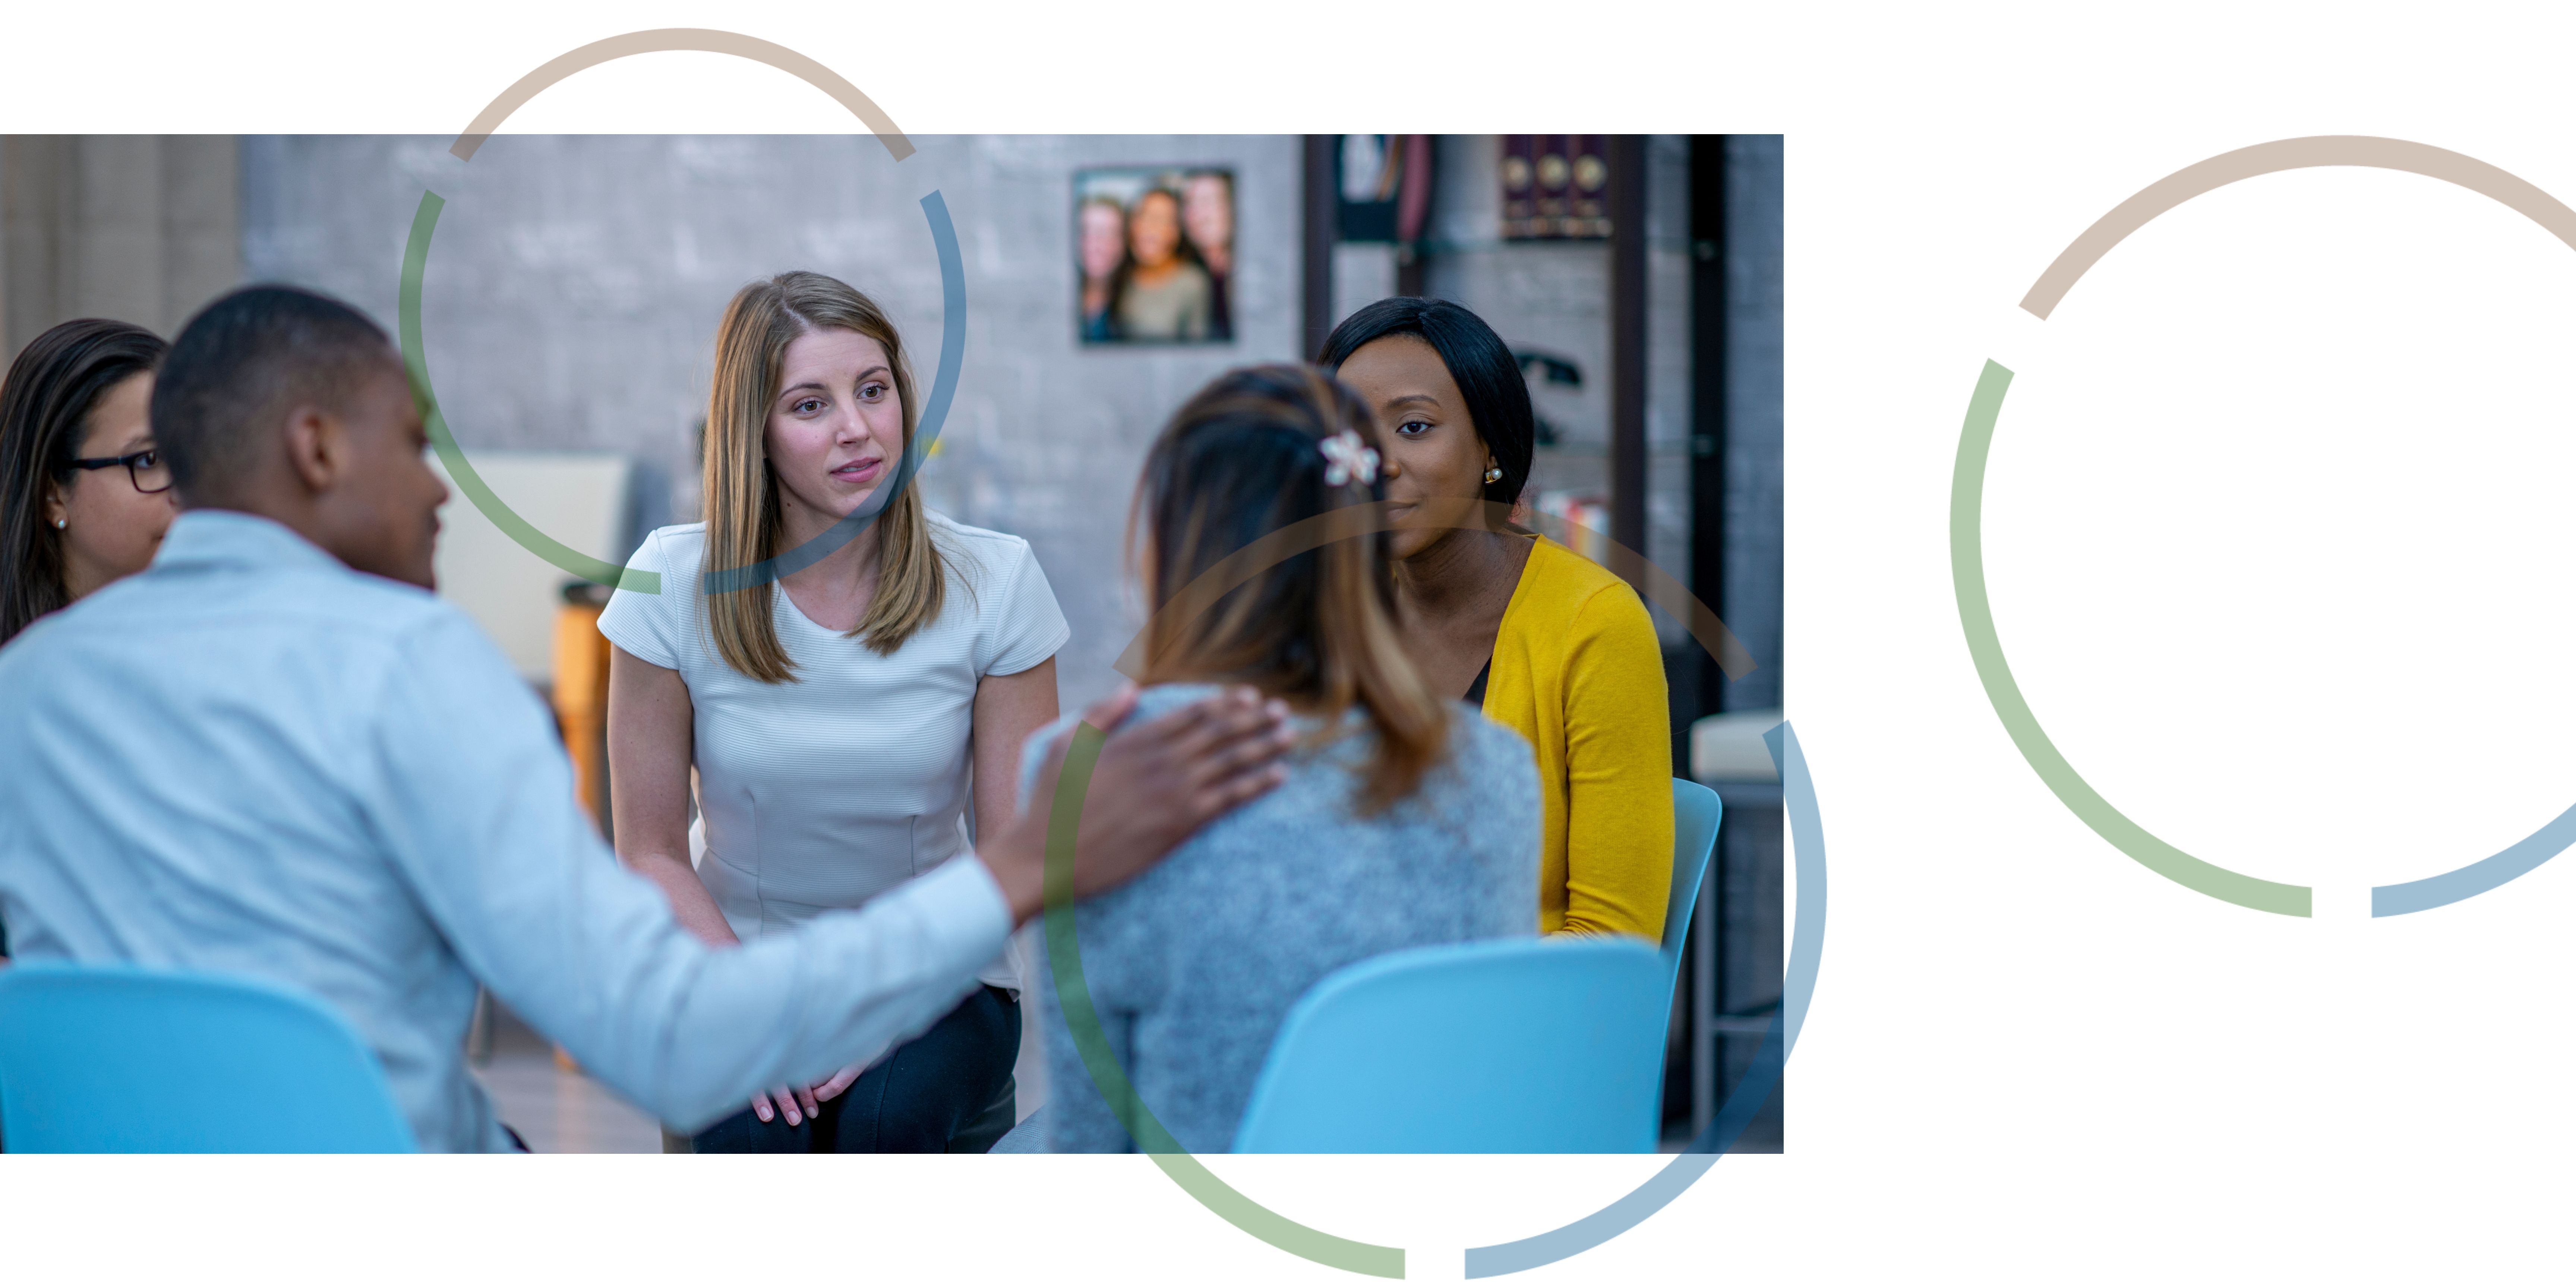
top-left (600, 512), bottom-right (1071, 989)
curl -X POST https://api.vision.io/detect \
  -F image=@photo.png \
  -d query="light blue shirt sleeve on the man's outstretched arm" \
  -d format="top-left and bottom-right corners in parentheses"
top-left (363, 616), bottom-right (1010, 1128)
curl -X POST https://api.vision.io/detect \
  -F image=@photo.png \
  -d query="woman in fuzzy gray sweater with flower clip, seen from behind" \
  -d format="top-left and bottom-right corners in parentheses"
top-left (1015, 366), bottom-right (1538, 1152)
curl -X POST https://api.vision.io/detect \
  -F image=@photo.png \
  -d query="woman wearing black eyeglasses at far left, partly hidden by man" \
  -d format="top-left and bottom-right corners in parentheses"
top-left (0, 317), bottom-right (178, 961)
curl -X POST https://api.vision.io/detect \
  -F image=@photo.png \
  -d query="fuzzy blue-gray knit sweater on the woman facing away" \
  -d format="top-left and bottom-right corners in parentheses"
top-left (1020, 685), bottom-right (1538, 1154)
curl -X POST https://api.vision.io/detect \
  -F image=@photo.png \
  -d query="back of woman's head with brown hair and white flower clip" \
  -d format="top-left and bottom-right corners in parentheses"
top-left (1128, 363), bottom-right (1448, 814)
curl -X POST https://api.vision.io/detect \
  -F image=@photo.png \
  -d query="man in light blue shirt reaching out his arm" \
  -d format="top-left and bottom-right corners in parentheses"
top-left (0, 286), bottom-right (1288, 1149)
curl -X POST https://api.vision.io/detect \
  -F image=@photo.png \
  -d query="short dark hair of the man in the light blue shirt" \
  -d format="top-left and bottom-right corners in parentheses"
top-left (152, 286), bottom-right (399, 500)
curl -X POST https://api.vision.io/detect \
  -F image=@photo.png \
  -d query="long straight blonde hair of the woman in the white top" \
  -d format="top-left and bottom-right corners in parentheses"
top-left (706, 273), bottom-right (948, 685)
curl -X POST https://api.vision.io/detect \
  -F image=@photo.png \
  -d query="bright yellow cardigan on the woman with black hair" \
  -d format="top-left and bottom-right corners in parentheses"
top-left (1484, 536), bottom-right (1672, 940)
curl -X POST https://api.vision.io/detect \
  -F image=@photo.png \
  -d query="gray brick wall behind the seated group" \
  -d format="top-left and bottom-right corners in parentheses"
top-left (242, 134), bottom-right (1690, 703)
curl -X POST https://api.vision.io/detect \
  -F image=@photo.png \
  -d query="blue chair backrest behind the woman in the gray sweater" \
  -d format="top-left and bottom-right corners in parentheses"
top-left (1234, 938), bottom-right (1664, 1154)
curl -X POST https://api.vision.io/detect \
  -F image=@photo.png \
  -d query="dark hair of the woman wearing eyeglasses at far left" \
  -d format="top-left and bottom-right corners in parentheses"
top-left (0, 317), bottom-right (170, 644)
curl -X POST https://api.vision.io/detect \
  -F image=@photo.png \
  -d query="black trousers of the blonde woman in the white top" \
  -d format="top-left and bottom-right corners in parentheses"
top-left (690, 984), bottom-right (1020, 1154)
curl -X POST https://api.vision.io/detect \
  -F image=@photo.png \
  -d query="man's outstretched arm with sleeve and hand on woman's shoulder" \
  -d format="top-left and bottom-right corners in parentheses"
top-left (371, 618), bottom-right (1291, 1126)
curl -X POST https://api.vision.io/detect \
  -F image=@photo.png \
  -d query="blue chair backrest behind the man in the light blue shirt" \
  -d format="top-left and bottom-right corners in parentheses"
top-left (0, 963), bottom-right (415, 1154)
